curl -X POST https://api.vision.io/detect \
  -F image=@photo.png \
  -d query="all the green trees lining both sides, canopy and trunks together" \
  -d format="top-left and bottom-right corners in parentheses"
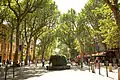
top-left (0, 0), bottom-right (120, 64)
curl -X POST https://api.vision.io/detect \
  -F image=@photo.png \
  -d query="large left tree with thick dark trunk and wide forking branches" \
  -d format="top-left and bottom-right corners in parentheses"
top-left (4, 0), bottom-right (46, 64)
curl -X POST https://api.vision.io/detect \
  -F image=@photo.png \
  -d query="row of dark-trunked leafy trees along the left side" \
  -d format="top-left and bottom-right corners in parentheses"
top-left (0, 0), bottom-right (59, 64)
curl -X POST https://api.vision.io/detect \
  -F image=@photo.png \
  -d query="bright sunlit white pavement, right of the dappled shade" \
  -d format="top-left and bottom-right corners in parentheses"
top-left (25, 66), bottom-right (118, 80)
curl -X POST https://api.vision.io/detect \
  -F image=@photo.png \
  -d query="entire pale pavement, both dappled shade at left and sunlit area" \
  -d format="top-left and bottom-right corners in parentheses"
top-left (0, 65), bottom-right (118, 80)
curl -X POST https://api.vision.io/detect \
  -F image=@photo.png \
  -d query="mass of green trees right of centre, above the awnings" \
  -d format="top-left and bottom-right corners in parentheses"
top-left (57, 0), bottom-right (120, 57)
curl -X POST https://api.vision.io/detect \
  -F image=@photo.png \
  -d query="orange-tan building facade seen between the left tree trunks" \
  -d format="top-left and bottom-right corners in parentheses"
top-left (0, 24), bottom-right (33, 63)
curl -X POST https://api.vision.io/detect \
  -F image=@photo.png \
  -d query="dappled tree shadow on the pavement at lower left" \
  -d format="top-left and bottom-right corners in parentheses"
top-left (0, 67), bottom-right (49, 80)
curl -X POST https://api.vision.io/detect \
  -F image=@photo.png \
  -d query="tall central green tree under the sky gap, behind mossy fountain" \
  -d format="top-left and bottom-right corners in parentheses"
top-left (57, 9), bottom-right (78, 58)
